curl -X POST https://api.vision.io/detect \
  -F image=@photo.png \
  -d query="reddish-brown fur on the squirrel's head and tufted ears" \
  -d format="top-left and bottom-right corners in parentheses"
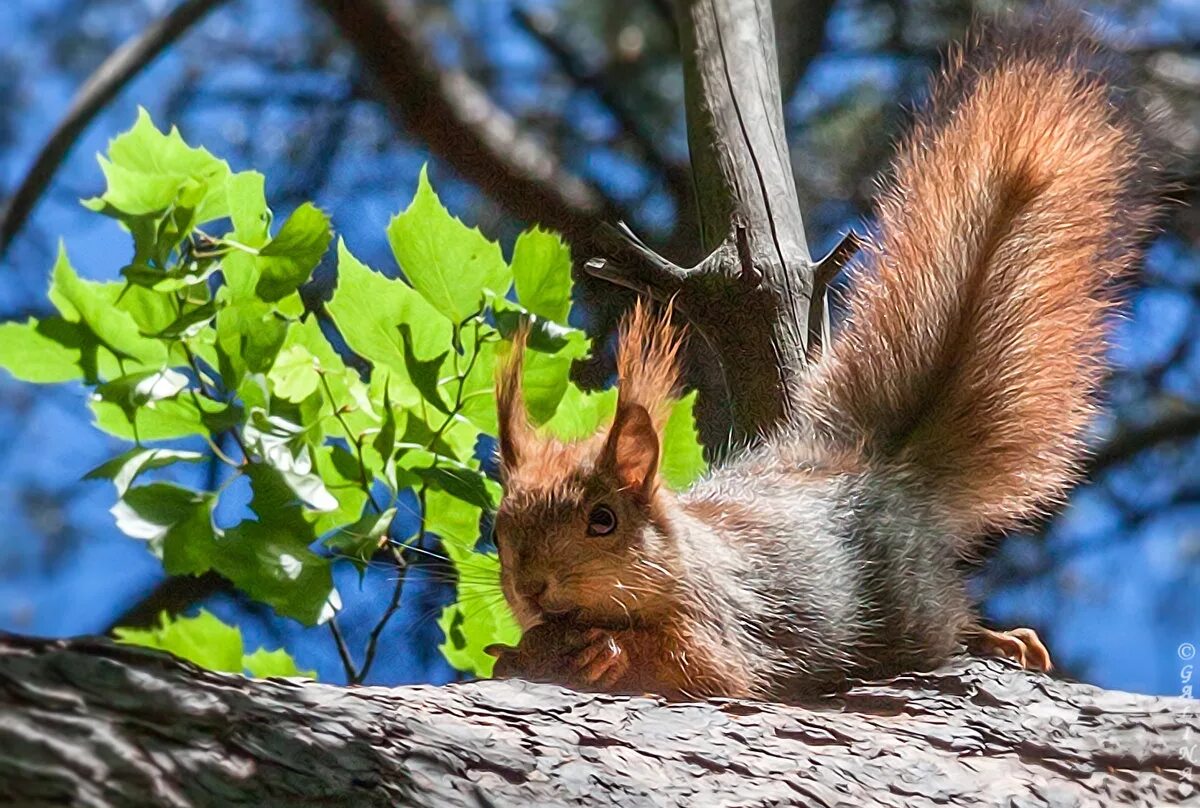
top-left (497, 304), bottom-right (679, 626)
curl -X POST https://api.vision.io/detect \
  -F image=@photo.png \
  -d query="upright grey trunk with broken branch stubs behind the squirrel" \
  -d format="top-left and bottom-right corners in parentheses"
top-left (587, 0), bottom-right (845, 441)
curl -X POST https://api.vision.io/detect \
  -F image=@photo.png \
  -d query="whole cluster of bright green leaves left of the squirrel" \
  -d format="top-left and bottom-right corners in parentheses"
top-left (0, 110), bottom-right (703, 678)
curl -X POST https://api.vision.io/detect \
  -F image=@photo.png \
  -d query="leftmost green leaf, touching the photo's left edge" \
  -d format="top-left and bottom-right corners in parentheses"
top-left (0, 317), bottom-right (100, 384)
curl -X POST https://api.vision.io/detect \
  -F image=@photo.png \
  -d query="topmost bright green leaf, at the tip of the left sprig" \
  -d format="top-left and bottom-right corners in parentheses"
top-left (85, 108), bottom-right (229, 223)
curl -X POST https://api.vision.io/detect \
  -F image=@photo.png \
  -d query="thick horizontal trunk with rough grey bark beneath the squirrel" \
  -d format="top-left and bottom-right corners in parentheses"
top-left (0, 636), bottom-right (1200, 807)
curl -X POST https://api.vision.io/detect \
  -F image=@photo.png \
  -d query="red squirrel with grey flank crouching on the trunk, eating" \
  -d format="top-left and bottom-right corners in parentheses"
top-left (482, 17), bottom-right (1153, 701)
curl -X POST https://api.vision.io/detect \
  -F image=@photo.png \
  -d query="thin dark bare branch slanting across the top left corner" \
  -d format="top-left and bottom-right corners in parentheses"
top-left (0, 0), bottom-right (226, 258)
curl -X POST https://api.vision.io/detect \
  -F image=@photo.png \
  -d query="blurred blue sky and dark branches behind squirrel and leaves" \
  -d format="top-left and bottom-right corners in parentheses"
top-left (0, 0), bottom-right (1200, 694)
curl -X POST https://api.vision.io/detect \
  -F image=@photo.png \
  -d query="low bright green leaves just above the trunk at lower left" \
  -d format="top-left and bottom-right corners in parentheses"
top-left (113, 609), bottom-right (316, 678)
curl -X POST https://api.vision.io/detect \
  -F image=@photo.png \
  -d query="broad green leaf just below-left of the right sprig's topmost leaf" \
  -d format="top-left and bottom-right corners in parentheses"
top-left (329, 236), bottom-right (454, 408)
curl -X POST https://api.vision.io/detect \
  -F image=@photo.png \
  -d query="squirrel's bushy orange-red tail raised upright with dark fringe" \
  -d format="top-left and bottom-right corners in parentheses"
top-left (799, 20), bottom-right (1151, 549)
